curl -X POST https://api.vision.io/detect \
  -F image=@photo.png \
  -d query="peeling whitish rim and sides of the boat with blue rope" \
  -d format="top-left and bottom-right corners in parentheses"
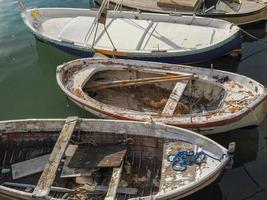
top-left (0, 119), bottom-right (230, 200)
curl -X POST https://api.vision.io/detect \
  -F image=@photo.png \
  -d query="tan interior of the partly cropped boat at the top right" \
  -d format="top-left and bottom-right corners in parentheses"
top-left (103, 0), bottom-right (264, 14)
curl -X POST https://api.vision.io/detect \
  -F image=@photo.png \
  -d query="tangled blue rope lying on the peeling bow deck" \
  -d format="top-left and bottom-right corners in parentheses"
top-left (168, 149), bottom-right (226, 171)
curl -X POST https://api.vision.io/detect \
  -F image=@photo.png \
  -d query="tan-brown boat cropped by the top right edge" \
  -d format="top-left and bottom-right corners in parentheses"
top-left (95, 0), bottom-right (267, 25)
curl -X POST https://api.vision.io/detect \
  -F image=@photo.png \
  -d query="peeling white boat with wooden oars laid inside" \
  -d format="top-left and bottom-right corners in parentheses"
top-left (57, 59), bottom-right (267, 134)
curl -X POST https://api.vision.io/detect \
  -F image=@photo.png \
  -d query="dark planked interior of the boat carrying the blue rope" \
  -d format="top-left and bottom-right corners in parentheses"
top-left (0, 119), bottom-right (205, 199)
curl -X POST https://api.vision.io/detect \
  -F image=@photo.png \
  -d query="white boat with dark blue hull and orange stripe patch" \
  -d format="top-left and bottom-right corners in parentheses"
top-left (19, 0), bottom-right (241, 63)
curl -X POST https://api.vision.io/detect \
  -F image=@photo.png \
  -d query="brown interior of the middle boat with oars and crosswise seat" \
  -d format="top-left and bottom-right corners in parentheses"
top-left (83, 68), bottom-right (226, 116)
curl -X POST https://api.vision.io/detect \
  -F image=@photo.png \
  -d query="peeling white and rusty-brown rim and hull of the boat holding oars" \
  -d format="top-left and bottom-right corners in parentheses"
top-left (57, 59), bottom-right (267, 135)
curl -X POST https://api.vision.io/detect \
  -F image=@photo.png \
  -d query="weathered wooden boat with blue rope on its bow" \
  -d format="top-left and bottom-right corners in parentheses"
top-left (0, 117), bottom-right (229, 200)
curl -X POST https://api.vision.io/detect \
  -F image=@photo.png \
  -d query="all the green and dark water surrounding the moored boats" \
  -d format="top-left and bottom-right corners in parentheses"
top-left (0, 0), bottom-right (267, 200)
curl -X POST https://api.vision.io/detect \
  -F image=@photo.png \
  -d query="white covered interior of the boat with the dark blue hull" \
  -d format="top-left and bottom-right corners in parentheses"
top-left (31, 9), bottom-right (236, 53)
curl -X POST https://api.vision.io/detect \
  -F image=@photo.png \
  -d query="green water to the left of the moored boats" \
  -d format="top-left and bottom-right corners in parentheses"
top-left (0, 0), bottom-right (90, 120)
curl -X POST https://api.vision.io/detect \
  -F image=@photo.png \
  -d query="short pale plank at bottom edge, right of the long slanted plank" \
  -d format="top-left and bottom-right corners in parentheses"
top-left (105, 162), bottom-right (123, 200)
